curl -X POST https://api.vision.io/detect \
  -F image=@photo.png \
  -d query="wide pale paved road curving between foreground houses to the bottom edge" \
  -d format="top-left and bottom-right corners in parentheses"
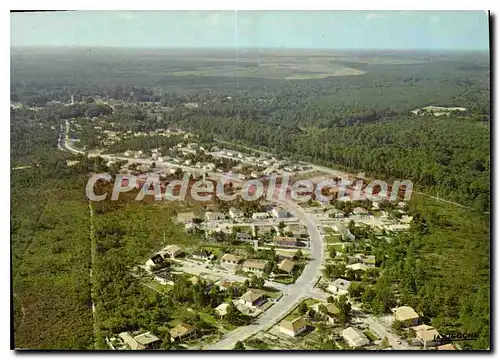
top-left (205, 200), bottom-right (324, 350)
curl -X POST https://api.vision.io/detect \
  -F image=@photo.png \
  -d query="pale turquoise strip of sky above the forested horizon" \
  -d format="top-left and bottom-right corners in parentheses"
top-left (11, 11), bottom-right (489, 50)
